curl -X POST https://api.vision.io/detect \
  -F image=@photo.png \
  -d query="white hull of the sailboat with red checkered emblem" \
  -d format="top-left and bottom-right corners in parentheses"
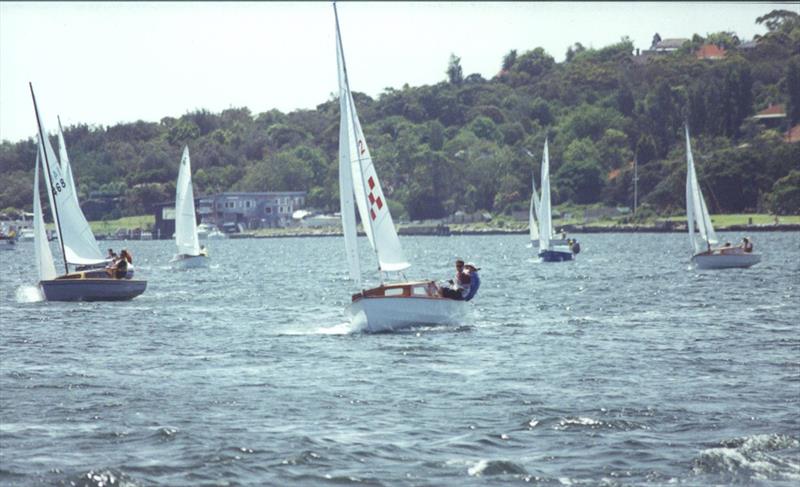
top-left (349, 296), bottom-right (467, 332)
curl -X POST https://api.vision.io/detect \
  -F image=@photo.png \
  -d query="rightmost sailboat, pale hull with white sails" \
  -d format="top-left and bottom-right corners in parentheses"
top-left (686, 125), bottom-right (761, 269)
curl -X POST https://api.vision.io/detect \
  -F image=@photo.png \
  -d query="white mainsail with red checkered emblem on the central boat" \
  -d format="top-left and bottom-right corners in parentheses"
top-left (334, 5), bottom-right (411, 272)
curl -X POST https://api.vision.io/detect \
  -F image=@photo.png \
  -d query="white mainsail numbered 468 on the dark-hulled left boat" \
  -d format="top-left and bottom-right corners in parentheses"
top-left (39, 124), bottom-right (105, 265)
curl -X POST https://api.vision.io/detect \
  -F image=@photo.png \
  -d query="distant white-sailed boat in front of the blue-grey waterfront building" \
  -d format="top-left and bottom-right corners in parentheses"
top-left (170, 146), bottom-right (208, 269)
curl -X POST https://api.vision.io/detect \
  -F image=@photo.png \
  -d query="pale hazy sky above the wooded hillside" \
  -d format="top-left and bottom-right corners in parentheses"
top-left (0, 1), bottom-right (800, 142)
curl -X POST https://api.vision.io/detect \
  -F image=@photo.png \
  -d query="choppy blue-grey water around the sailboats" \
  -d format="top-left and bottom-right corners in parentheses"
top-left (0, 233), bottom-right (800, 486)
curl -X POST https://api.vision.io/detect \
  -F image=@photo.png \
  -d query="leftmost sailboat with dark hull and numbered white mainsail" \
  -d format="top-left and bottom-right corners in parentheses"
top-left (30, 85), bottom-right (147, 301)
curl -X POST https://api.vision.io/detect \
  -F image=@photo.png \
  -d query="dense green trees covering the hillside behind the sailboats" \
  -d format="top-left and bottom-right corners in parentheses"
top-left (0, 11), bottom-right (800, 219)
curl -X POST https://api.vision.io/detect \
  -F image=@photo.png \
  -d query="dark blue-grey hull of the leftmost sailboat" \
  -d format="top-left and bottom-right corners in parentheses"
top-left (39, 279), bottom-right (147, 301)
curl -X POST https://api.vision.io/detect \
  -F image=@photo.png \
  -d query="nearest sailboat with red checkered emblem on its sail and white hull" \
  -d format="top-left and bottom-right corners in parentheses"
top-left (333, 4), bottom-right (477, 332)
